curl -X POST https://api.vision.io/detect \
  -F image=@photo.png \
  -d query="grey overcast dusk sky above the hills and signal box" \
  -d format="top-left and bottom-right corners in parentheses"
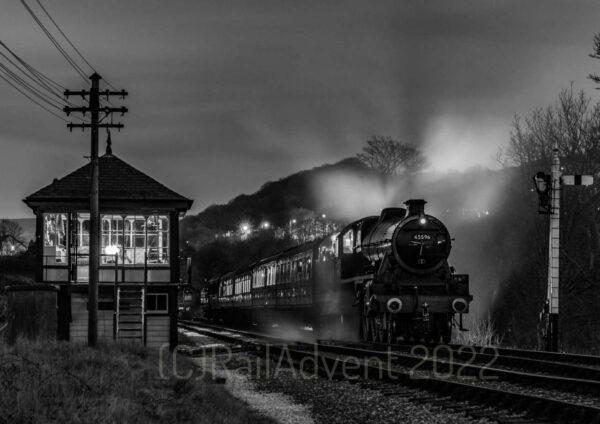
top-left (0, 0), bottom-right (600, 218)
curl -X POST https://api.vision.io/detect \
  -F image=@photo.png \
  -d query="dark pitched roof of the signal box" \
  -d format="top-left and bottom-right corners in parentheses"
top-left (23, 153), bottom-right (192, 212)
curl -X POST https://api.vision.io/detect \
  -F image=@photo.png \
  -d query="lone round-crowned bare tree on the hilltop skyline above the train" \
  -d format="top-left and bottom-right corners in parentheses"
top-left (356, 136), bottom-right (426, 176)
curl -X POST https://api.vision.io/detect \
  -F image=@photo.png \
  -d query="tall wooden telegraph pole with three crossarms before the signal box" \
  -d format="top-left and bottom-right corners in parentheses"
top-left (63, 72), bottom-right (127, 347)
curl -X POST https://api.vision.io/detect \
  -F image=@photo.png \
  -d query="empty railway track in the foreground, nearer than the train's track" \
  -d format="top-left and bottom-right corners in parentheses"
top-left (182, 322), bottom-right (600, 423)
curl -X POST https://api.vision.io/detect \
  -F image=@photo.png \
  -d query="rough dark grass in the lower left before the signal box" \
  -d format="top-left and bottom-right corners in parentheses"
top-left (0, 340), bottom-right (272, 424)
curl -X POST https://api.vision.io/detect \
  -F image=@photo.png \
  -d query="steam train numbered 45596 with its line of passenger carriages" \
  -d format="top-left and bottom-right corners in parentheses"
top-left (201, 199), bottom-right (473, 343)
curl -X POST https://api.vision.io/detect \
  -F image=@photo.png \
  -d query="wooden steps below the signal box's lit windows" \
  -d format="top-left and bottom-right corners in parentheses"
top-left (116, 287), bottom-right (144, 344)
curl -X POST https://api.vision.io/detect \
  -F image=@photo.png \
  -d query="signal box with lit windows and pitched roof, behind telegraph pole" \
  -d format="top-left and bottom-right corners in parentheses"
top-left (24, 151), bottom-right (192, 346)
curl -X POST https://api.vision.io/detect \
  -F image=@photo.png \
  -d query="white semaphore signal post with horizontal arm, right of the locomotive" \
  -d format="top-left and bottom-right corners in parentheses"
top-left (533, 144), bottom-right (594, 352)
